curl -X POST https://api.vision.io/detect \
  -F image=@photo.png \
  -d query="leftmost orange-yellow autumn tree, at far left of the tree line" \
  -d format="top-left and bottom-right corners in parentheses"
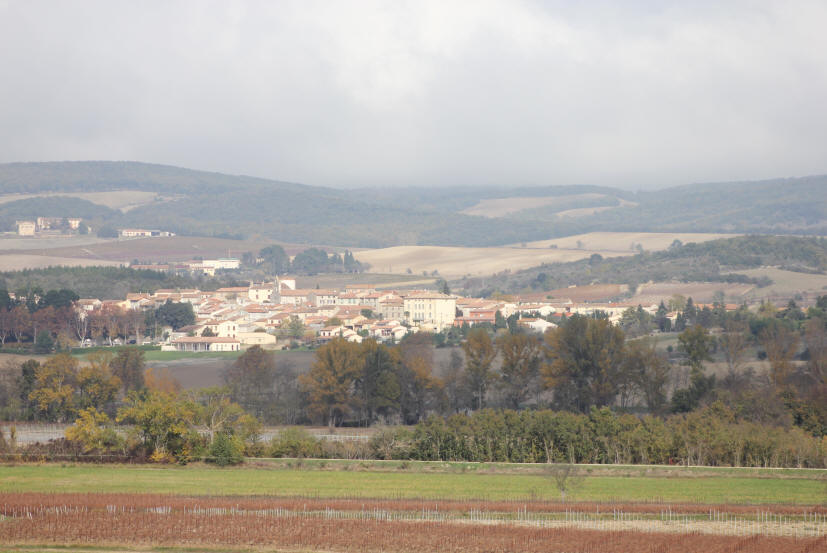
top-left (29, 353), bottom-right (78, 422)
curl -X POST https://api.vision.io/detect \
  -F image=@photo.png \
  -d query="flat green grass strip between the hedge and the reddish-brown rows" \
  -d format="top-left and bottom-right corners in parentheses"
top-left (0, 463), bottom-right (827, 505)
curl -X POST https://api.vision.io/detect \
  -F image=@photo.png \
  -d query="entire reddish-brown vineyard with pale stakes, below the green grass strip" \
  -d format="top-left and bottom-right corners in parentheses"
top-left (0, 494), bottom-right (827, 553)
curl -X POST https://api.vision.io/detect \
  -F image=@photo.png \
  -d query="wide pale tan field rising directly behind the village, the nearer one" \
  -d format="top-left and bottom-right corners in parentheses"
top-left (354, 246), bottom-right (628, 278)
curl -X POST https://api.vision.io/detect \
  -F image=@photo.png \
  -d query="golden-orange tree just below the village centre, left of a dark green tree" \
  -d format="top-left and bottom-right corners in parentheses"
top-left (299, 338), bottom-right (364, 431)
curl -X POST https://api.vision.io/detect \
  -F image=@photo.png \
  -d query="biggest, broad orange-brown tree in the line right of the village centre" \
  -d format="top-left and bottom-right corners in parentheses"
top-left (541, 315), bottom-right (625, 413)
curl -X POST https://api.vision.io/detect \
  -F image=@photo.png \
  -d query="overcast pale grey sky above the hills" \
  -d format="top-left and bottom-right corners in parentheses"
top-left (0, 0), bottom-right (827, 189)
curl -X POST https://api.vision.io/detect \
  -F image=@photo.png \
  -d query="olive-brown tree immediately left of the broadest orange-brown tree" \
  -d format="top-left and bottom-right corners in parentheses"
top-left (497, 333), bottom-right (543, 409)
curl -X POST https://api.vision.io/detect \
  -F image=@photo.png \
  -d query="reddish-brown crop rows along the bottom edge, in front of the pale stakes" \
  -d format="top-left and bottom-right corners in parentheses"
top-left (0, 510), bottom-right (827, 553)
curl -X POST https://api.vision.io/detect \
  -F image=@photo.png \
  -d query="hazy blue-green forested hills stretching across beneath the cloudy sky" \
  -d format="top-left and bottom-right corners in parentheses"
top-left (0, 162), bottom-right (827, 247)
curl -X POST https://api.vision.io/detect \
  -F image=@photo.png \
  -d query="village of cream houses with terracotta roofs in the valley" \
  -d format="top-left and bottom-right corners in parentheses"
top-left (69, 277), bottom-right (734, 352)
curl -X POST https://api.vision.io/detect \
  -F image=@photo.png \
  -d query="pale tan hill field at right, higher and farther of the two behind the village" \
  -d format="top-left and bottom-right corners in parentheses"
top-left (515, 232), bottom-right (738, 255)
